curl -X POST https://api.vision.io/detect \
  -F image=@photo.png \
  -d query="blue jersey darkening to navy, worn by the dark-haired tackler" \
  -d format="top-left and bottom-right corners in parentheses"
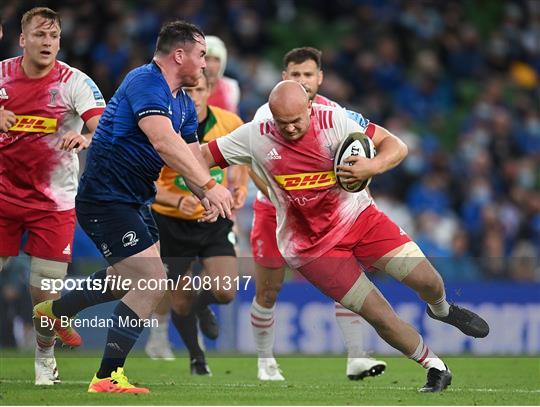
top-left (76, 63), bottom-right (198, 204)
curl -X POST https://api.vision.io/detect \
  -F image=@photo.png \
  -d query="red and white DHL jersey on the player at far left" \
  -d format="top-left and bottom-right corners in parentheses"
top-left (0, 57), bottom-right (105, 211)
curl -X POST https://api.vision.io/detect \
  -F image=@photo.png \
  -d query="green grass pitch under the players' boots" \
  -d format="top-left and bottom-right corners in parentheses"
top-left (0, 351), bottom-right (540, 405)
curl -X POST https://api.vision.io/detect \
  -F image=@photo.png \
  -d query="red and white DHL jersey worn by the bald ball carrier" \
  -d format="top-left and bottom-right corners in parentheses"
top-left (208, 104), bottom-right (372, 267)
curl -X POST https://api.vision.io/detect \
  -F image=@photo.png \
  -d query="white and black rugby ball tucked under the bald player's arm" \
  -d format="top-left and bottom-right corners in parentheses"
top-left (334, 132), bottom-right (376, 192)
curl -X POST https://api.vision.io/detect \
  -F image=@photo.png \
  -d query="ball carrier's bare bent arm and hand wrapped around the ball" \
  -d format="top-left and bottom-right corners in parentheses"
top-left (336, 123), bottom-right (408, 182)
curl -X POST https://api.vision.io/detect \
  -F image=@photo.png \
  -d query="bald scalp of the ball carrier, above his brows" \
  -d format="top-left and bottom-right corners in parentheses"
top-left (268, 80), bottom-right (309, 116)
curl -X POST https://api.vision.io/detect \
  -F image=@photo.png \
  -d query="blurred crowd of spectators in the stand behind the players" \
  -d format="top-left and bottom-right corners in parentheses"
top-left (0, 0), bottom-right (540, 288)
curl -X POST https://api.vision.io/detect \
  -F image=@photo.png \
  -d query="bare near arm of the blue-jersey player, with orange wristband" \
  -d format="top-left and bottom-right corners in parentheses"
top-left (139, 115), bottom-right (233, 217)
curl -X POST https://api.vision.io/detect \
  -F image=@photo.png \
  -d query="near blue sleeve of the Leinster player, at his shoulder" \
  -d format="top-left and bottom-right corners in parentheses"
top-left (125, 73), bottom-right (170, 121)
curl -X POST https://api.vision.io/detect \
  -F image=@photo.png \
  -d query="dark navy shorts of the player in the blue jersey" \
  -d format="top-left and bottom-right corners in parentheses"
top-left (75, 201), bottom-right (159, 265)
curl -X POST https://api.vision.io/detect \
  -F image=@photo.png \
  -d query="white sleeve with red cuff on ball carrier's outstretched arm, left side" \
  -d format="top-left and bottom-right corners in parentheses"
top-left (208, 122), bottom-right (255, 168)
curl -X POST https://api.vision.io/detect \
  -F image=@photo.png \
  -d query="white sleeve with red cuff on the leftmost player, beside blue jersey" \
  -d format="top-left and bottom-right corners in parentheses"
top-left (67, 68), bottom-right (105, 122)
